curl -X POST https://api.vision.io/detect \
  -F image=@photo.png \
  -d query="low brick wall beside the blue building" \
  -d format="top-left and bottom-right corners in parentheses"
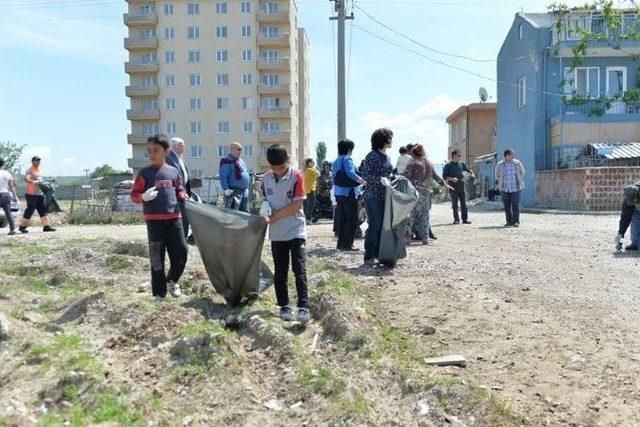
top-left (535, 167), bottom-right (640, 211)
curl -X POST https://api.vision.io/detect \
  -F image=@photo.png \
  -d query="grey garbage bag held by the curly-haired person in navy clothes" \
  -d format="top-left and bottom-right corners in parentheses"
top-left (378, 176), bottom-right (419, 267)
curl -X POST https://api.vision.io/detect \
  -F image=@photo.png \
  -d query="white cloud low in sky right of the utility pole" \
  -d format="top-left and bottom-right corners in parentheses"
top-left (357, 95), bottom-right (462, 163)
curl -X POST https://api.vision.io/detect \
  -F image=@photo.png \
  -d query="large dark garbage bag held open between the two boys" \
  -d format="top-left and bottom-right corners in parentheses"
top-left (185, 201), bottom-right (273, 306)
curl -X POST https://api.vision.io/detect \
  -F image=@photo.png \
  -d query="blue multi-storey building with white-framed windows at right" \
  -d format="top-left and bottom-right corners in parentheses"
top-left (497, 10), bottom-right (640, 205)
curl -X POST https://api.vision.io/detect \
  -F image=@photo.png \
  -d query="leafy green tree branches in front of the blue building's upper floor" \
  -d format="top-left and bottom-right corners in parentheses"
top-left (549, 0), bottom-right (640, 116)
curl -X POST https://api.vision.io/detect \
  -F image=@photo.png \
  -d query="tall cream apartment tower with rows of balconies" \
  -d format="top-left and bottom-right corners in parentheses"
top-left (124, 0), bottom-right (309, 176)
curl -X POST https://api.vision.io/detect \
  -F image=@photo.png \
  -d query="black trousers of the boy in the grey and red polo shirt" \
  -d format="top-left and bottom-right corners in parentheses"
top-left (271, 239), bottom-right (309, 308)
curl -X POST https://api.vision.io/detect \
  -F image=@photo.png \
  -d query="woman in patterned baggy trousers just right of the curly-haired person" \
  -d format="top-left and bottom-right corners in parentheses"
top-left (403, 144), bottom-right (451, 245)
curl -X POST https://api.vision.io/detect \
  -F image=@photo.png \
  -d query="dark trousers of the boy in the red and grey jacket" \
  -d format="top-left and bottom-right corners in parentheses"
top-left (147, 219), bottom-right (189, 298)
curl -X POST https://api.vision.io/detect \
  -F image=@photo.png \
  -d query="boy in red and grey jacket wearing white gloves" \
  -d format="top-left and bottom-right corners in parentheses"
top-left (131, 135), bottom-right (188, 302)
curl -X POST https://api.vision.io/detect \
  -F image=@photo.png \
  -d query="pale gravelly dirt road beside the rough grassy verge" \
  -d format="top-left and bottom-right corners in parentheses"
top-left (3, 205), bottom-right (640, 425)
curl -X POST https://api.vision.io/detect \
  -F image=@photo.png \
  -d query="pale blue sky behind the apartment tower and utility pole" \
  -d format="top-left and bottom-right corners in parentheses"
top-left (0, 0), bottom-right (582, 175)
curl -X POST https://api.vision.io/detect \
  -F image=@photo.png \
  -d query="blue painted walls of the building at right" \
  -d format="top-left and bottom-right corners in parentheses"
top-left (497, 14), bottom-right (640, 206)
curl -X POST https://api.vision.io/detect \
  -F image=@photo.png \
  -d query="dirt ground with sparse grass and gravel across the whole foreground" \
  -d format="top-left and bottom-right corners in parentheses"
top-left (0, 205), bottom-right (640, 425)
